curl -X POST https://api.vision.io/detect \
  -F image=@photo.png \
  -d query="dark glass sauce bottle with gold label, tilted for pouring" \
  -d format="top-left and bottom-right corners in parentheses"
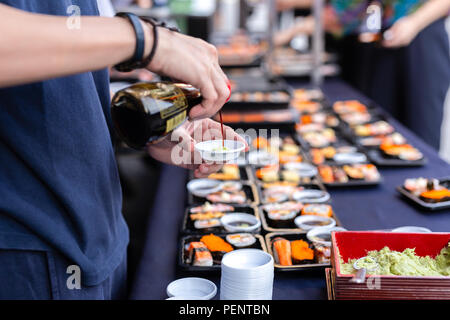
top-left (111, 82), bottom-right (202, 150)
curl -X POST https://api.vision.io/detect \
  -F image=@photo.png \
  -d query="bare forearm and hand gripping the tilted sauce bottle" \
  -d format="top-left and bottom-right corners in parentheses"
top-left (0, 5), bottom-right (230, 119)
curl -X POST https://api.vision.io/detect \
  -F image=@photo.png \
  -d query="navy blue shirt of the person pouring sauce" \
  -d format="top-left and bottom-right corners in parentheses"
top-left (0, 0), bottom-right (128, 285)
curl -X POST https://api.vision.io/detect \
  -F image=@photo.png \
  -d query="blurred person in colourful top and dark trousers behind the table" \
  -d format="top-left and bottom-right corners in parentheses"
top-left (275, 0), bottom-right (450, 150)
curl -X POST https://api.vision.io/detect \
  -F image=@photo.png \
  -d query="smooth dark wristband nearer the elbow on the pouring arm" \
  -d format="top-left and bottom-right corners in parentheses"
top-left (114, 12), bottom-right (145, 72)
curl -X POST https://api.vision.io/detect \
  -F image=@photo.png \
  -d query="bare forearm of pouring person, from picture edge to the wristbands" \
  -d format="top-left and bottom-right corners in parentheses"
top-left (0, 5), bottom-right (137, 87)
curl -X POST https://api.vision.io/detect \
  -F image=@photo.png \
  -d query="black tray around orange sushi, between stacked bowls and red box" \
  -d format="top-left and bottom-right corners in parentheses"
top-left (265, 232), bottom-right (331, 272)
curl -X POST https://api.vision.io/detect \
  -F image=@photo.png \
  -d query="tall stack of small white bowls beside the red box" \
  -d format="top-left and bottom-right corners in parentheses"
top-left (220, 249), bottom-right (274, 300)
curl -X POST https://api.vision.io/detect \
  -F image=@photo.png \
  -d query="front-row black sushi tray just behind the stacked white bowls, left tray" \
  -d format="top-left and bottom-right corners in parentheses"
top-left (178, 234), bottom-right (267, 272)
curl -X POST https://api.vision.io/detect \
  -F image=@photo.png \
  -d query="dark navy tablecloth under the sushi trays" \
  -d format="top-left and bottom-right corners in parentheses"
top-left (130, 80), bottom-right (450, 300)
